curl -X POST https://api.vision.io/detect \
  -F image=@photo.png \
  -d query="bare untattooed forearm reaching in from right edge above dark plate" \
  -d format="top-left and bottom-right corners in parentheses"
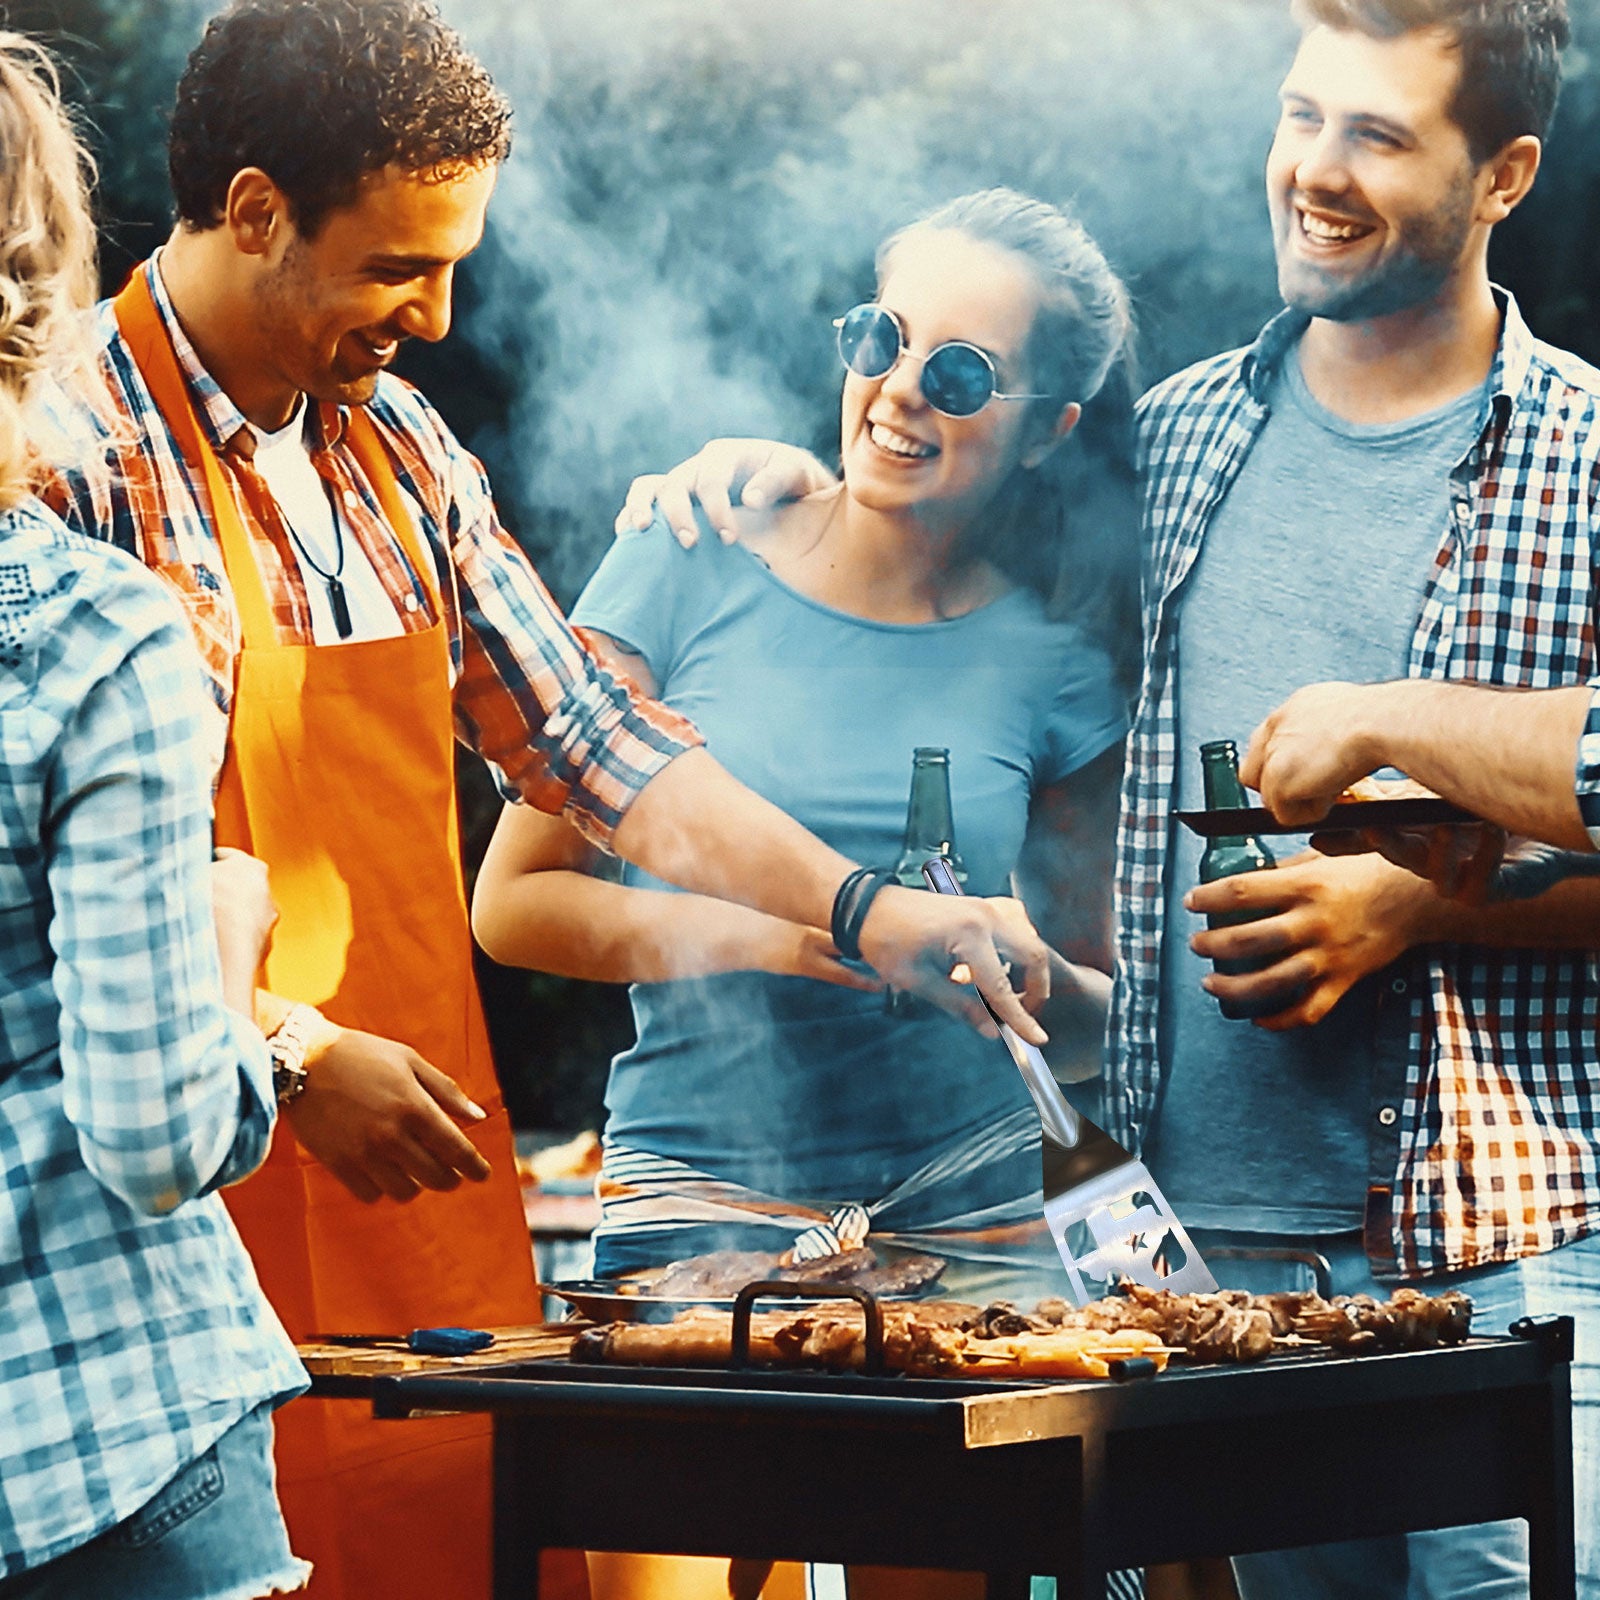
top-left (1363, 678), bottom-right (1594, 851)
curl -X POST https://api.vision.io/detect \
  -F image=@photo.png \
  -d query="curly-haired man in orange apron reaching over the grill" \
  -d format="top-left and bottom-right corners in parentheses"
top-left (40, 0), bottom-right (1046, 1600)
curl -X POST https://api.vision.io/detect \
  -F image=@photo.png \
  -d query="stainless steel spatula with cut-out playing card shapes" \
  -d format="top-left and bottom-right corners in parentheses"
top-left (922, 856), bottom-right (1216, 1306)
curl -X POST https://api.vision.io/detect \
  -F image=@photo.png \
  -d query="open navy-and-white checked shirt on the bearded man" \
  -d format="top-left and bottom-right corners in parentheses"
top-left (1107, 296), bottom-right (1600, 1277)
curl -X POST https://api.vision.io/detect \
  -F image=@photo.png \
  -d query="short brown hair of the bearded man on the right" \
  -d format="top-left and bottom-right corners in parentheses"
top-left (1294, 0), bottom-right (1571, 162)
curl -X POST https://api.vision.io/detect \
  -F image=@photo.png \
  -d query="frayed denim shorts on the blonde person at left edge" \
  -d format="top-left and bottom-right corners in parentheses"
top-left (0, 1406), bottom-right (310, 1600)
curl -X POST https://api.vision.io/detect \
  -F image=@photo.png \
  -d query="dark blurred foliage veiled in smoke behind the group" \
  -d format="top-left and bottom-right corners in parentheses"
top-left (18, 0), bottom-right (1600, 1128)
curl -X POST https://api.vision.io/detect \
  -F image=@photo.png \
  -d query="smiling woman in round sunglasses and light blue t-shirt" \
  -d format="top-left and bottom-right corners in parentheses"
top-left (474, 190), bottom-right (1136, 1600)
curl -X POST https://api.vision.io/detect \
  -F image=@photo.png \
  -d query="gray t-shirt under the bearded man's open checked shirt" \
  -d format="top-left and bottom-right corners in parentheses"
top-left (1150, 352), bottom-right (1486, 1234)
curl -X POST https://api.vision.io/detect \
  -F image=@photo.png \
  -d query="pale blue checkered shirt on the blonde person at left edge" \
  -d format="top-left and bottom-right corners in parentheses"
top-left (0, 502), bottom-right (306, 1578)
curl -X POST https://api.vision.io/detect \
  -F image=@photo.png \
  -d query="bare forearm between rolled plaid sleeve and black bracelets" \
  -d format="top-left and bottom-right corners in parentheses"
top-left (611, 750), bottom-right (851, 930)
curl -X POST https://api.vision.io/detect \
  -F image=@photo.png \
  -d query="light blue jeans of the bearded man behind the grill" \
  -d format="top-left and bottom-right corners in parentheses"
top-left (1192, 1229), bottom-right (1600, 1600)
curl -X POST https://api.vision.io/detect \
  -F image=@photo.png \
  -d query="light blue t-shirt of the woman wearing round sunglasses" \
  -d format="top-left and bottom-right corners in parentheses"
top-left (573, 520), bottom-right (1126, 1200)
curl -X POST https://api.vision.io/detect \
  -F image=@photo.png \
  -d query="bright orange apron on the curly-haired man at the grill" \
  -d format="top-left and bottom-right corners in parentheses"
top-left (117, 272), bottom-right (539, 1600)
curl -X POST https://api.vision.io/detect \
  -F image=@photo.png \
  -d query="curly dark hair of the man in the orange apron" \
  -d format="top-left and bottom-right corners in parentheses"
top-left (168, 0), bottom-right (510, 237)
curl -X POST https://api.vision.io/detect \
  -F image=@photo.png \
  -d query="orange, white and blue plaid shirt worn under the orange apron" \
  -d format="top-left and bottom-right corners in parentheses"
top-left (42, 261), bottom-right (699, 846)
